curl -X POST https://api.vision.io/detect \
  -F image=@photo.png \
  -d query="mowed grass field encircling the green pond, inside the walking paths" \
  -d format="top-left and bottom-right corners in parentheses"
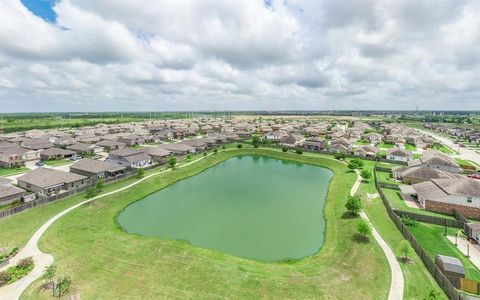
top-left (0, 149), bottom-right (390, 299)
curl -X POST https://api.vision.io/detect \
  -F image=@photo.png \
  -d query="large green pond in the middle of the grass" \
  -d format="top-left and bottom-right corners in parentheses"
top-left (117, 156), bottom-right (333, 262)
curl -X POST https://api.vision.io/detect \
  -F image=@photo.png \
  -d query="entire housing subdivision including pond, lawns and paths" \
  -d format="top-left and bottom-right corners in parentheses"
top-left (0, 113), bottom-right (480, 299)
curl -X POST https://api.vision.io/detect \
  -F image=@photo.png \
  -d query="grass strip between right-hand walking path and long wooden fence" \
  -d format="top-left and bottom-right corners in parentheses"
top-left (358, 161), bottom-right (446, 299)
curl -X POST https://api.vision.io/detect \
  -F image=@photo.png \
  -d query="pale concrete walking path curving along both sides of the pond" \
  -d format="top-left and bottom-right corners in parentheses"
top-left (0, 148), bottom-right (404, 300)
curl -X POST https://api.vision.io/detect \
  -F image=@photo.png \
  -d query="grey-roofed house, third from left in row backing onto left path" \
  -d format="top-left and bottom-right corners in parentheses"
top-left (70, 159), bottom-right (126, 179)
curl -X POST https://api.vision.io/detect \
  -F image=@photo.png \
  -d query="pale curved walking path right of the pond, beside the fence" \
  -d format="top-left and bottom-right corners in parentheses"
top-left (350, 171), bottom-right (404, 300)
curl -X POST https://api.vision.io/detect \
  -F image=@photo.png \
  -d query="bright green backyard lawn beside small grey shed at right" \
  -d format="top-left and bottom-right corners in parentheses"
top-left (409, 222), bottom-right (480, 281)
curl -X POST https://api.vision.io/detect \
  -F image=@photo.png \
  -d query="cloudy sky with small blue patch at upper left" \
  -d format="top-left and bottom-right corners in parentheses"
top-left (0, 0), bottom-right (480, 112)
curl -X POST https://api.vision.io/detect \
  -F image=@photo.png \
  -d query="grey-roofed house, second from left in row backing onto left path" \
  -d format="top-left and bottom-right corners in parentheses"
top-left (17, 168), bottom-right (87, 196)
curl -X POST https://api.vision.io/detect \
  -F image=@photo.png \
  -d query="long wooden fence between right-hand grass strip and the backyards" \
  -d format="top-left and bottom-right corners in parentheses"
top-left (373, 170), bottom-right (464, 300)
